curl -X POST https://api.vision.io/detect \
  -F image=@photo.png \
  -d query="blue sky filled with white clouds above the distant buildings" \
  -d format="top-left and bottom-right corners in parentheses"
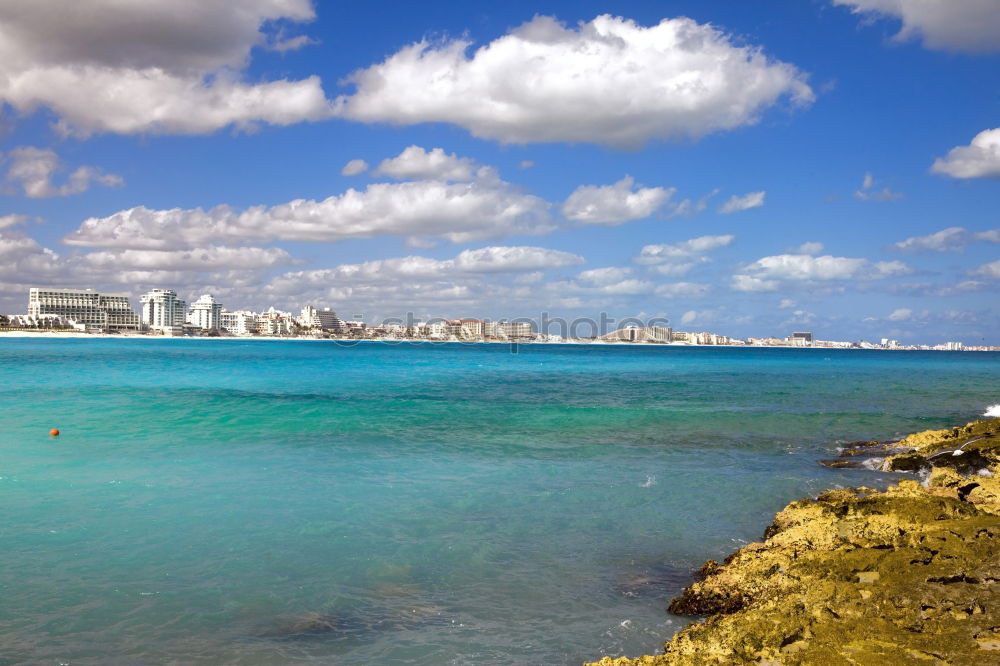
top-left (0, 0), bottom-right (1000, 344)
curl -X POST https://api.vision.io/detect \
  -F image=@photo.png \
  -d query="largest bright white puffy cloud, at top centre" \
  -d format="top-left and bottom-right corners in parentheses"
top-left (336, 15), bottom-right (814, 147)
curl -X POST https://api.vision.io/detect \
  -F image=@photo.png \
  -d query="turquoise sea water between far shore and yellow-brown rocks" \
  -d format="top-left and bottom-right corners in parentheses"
top-left (0, 339), bottom-right (1000, 665)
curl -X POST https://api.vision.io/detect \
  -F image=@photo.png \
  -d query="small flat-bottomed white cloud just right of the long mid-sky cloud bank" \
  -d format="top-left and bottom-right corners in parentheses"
top-left (562, 176), bottom-right (674, 225)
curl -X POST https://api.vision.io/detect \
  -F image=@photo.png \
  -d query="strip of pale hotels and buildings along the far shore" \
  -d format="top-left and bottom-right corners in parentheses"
top-left (9, 287), bottom-right (1000, 351)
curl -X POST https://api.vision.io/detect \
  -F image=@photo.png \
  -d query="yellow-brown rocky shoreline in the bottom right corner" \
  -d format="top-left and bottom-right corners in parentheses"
top-left (585, 419), bottom-right (1000, 666)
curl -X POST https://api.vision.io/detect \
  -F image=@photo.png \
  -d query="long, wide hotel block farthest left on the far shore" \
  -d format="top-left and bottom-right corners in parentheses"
top-left (28, 287), bottom-right (139, 331)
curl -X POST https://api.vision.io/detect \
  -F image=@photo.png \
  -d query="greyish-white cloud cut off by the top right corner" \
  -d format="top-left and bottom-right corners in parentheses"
top-left (833, 0), bottom-right (1000, 53)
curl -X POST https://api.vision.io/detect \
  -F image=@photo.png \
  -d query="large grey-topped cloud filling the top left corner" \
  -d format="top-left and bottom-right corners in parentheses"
top-left (0, 0), bottom-right (331, 137)
